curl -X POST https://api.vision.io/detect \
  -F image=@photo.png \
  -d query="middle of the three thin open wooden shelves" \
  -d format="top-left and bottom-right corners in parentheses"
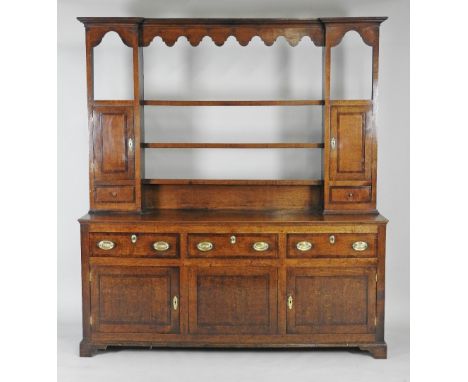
top-left (141, 142), bottom-right (324, 149)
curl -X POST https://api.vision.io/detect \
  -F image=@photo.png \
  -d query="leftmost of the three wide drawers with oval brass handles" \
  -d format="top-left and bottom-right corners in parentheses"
top-left (89, 233), bottom-right (179, 258)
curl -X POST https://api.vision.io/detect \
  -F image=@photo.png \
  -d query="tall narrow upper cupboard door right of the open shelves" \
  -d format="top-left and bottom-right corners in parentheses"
top-left (330, 104), bottom-right (373, 181)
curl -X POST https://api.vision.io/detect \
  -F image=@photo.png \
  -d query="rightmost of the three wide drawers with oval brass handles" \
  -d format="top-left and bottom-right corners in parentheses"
top-left (287, 233), bottom-right (377, 258)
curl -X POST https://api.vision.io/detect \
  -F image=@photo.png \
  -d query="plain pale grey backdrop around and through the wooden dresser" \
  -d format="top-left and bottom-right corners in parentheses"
top-left (58, 0), bottom-right (409, 381)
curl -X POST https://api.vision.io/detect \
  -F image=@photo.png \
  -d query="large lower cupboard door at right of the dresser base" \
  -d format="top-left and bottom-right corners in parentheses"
top-left (286, 267), bottom-right (376, 334)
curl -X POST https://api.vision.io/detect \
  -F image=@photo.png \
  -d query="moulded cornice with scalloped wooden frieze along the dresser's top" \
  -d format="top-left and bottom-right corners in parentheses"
top-left (78, 17), bottom-right (387, 47)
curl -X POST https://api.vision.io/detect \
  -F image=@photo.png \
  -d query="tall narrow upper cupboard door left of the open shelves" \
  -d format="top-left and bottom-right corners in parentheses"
top-left (93, 106), bottom-right (135, 181)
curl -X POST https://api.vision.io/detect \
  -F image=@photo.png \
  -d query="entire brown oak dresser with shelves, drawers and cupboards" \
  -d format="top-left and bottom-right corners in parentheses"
top-left (78, 17), bottom-right (387, 358)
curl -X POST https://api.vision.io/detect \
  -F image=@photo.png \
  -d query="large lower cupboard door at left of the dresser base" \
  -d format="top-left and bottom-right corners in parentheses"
top-left (91, 265), bottom-right (179, 333)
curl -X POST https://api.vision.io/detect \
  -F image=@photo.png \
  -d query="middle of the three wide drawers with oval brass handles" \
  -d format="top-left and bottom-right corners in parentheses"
top-left (187, 233), bottom-right (278, 258)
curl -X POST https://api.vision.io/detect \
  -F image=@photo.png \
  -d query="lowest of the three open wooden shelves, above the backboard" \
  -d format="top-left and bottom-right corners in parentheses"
top-left (141, 179), bottom-right (323, 186)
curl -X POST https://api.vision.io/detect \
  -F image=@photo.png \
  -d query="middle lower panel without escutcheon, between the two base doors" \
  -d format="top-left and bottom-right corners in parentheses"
top-left (189, 267), bottom-right (277, 334)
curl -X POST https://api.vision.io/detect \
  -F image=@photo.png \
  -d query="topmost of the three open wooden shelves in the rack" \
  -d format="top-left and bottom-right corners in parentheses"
top-left (141, 100), bottom-right (325, 106)
